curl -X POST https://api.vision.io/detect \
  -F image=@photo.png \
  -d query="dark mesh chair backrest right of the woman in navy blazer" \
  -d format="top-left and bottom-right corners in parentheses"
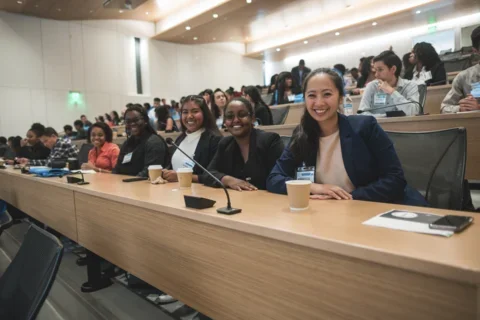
top-left (387, 128), bottom-right (467, 210)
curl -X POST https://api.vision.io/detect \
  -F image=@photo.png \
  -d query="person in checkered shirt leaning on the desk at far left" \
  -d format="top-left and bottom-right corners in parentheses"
top-left (17, 127), bottom-right (78, 167)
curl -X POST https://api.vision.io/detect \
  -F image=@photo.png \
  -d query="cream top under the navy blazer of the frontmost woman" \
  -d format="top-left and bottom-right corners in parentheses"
top-left (315, 130), bottom-right (355, 193)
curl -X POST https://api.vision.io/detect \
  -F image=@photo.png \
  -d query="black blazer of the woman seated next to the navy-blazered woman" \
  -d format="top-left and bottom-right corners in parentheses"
top-left (203, 129), bottom-right (283, 190)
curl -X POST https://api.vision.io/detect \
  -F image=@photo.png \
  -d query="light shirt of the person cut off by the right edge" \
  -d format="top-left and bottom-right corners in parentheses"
top-left (442, 64), bottom-right (480, 113)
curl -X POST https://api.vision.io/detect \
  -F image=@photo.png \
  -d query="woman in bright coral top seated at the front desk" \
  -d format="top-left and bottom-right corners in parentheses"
top-left (82, 122), bottom-right (120, 173)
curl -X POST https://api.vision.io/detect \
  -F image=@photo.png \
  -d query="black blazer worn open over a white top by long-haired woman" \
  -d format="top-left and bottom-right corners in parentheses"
top-left (172, 131), bottom-right (222, 183)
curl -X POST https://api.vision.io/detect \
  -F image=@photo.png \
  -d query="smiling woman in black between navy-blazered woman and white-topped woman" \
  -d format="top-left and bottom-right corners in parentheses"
top-left (203, 98), bottom-right (283, 191)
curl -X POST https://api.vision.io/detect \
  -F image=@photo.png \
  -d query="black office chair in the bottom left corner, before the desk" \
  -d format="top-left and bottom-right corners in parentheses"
top-left (0, 225), bottom-right (63, 320)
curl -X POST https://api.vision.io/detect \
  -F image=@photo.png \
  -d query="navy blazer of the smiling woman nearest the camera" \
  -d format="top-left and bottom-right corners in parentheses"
top-left (267, 115), bottom-right (428, 206)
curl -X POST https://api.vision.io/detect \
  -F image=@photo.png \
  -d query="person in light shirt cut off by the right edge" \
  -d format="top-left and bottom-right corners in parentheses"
top-left (442, 27), bottom-right (480, 113)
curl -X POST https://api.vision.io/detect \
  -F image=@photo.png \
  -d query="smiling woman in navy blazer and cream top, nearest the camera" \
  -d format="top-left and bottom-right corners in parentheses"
top-left (267, 69), bottom-right (426, 205)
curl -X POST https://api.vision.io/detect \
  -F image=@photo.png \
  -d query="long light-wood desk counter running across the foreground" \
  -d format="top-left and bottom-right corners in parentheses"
top-left (0, 169), bottom-right (480, 320)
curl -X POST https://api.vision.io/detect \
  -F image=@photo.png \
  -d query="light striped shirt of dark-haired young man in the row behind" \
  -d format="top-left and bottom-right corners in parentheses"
top-left (358, 78), bottom-right (420, 116)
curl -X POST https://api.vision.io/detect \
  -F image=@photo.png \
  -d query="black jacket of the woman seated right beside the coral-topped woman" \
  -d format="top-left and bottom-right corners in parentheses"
top-left (113, 133), bottom-right (170, 177)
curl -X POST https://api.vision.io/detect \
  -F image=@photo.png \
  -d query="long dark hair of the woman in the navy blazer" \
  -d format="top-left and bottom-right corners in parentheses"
top-left (290, 68), bottom-right (343, 163)
